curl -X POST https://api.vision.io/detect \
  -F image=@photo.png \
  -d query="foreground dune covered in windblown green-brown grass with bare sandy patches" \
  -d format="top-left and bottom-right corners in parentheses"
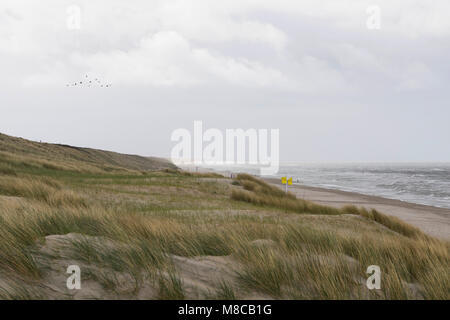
top-left (0, 134), bottom-right (450, 299)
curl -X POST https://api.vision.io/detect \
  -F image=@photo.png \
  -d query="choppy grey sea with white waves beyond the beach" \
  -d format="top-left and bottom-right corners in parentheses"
top-left (200, 163), bottom-right (450, 209)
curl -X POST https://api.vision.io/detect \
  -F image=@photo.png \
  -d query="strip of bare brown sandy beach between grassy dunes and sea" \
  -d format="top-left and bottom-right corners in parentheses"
top-left (265, 178), bottom-right (450, 240)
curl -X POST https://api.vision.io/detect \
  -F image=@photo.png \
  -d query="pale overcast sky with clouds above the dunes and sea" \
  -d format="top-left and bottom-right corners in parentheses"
top-left (0, 0), bottom-right (450, 161)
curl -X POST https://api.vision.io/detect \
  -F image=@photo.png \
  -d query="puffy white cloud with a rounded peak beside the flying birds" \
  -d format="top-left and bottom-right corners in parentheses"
top-left (71, 31), bottom-right (288, 87)
